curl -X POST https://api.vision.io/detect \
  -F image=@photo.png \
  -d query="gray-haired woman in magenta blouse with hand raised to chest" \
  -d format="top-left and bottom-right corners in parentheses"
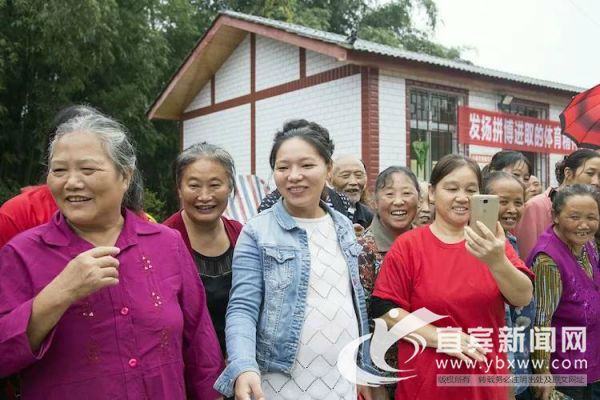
top-left (0, 108), bottom-right (223, 399)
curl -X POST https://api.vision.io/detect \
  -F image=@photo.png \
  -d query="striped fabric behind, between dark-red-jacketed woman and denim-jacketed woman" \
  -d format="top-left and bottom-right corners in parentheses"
top-left (224, 175), bottom-right (270, 224)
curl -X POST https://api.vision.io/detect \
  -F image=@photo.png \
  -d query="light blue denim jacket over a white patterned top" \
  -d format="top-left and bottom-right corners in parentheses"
top-left (215, 199), bottom-right (373, 396)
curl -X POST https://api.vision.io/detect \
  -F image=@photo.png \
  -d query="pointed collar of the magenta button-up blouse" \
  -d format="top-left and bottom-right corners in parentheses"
top-left (41, 209), bottom-right (160, 251)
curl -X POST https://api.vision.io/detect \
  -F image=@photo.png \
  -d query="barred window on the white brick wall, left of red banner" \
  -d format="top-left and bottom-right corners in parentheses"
top-left (410, 87), bottom-right (464, 180)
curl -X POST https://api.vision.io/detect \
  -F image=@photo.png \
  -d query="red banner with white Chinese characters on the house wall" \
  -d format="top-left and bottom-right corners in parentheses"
top-left (458, 106), bottom-right (577, 154)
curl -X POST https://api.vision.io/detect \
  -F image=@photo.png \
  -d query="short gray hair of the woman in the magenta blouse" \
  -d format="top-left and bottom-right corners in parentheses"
top-left (48, 109), bottom-right (144, 212)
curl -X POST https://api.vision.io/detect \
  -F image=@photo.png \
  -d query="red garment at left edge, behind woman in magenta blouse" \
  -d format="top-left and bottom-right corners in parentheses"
top-left (0, 185), bottom-right (58, 247)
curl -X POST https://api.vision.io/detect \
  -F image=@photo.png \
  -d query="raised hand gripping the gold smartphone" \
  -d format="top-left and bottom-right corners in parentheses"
top-left (465, 221), bottom-right (506, 268)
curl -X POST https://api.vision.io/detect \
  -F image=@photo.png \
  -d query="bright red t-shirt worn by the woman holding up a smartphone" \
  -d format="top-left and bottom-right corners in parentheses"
top-left (373, 226), bottom-right (533, 400)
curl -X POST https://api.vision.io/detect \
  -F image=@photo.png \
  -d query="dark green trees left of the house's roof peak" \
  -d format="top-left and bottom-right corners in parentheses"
top-left (0, 0), bottom-right (209, 208)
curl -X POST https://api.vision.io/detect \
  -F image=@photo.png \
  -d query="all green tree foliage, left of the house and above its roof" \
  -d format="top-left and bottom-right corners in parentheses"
top-left (0, 0), bottom-right (460, 216)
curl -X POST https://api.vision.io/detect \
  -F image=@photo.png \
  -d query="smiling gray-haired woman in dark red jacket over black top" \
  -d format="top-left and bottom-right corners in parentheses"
top-left (164, 142), bottom-right (242, 353)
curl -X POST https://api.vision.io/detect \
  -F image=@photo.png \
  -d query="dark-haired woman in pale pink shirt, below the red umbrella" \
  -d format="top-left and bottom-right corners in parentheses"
top-left (513, 149), bottom-right (600, 260)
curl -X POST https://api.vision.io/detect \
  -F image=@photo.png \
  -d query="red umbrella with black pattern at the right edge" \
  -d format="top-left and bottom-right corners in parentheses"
top-left (560, 85), bottom-right (600, 148)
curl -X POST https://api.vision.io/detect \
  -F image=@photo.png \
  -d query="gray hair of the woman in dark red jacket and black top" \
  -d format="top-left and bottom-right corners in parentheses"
top-left (175, 142), bottom-right (236, 194)
